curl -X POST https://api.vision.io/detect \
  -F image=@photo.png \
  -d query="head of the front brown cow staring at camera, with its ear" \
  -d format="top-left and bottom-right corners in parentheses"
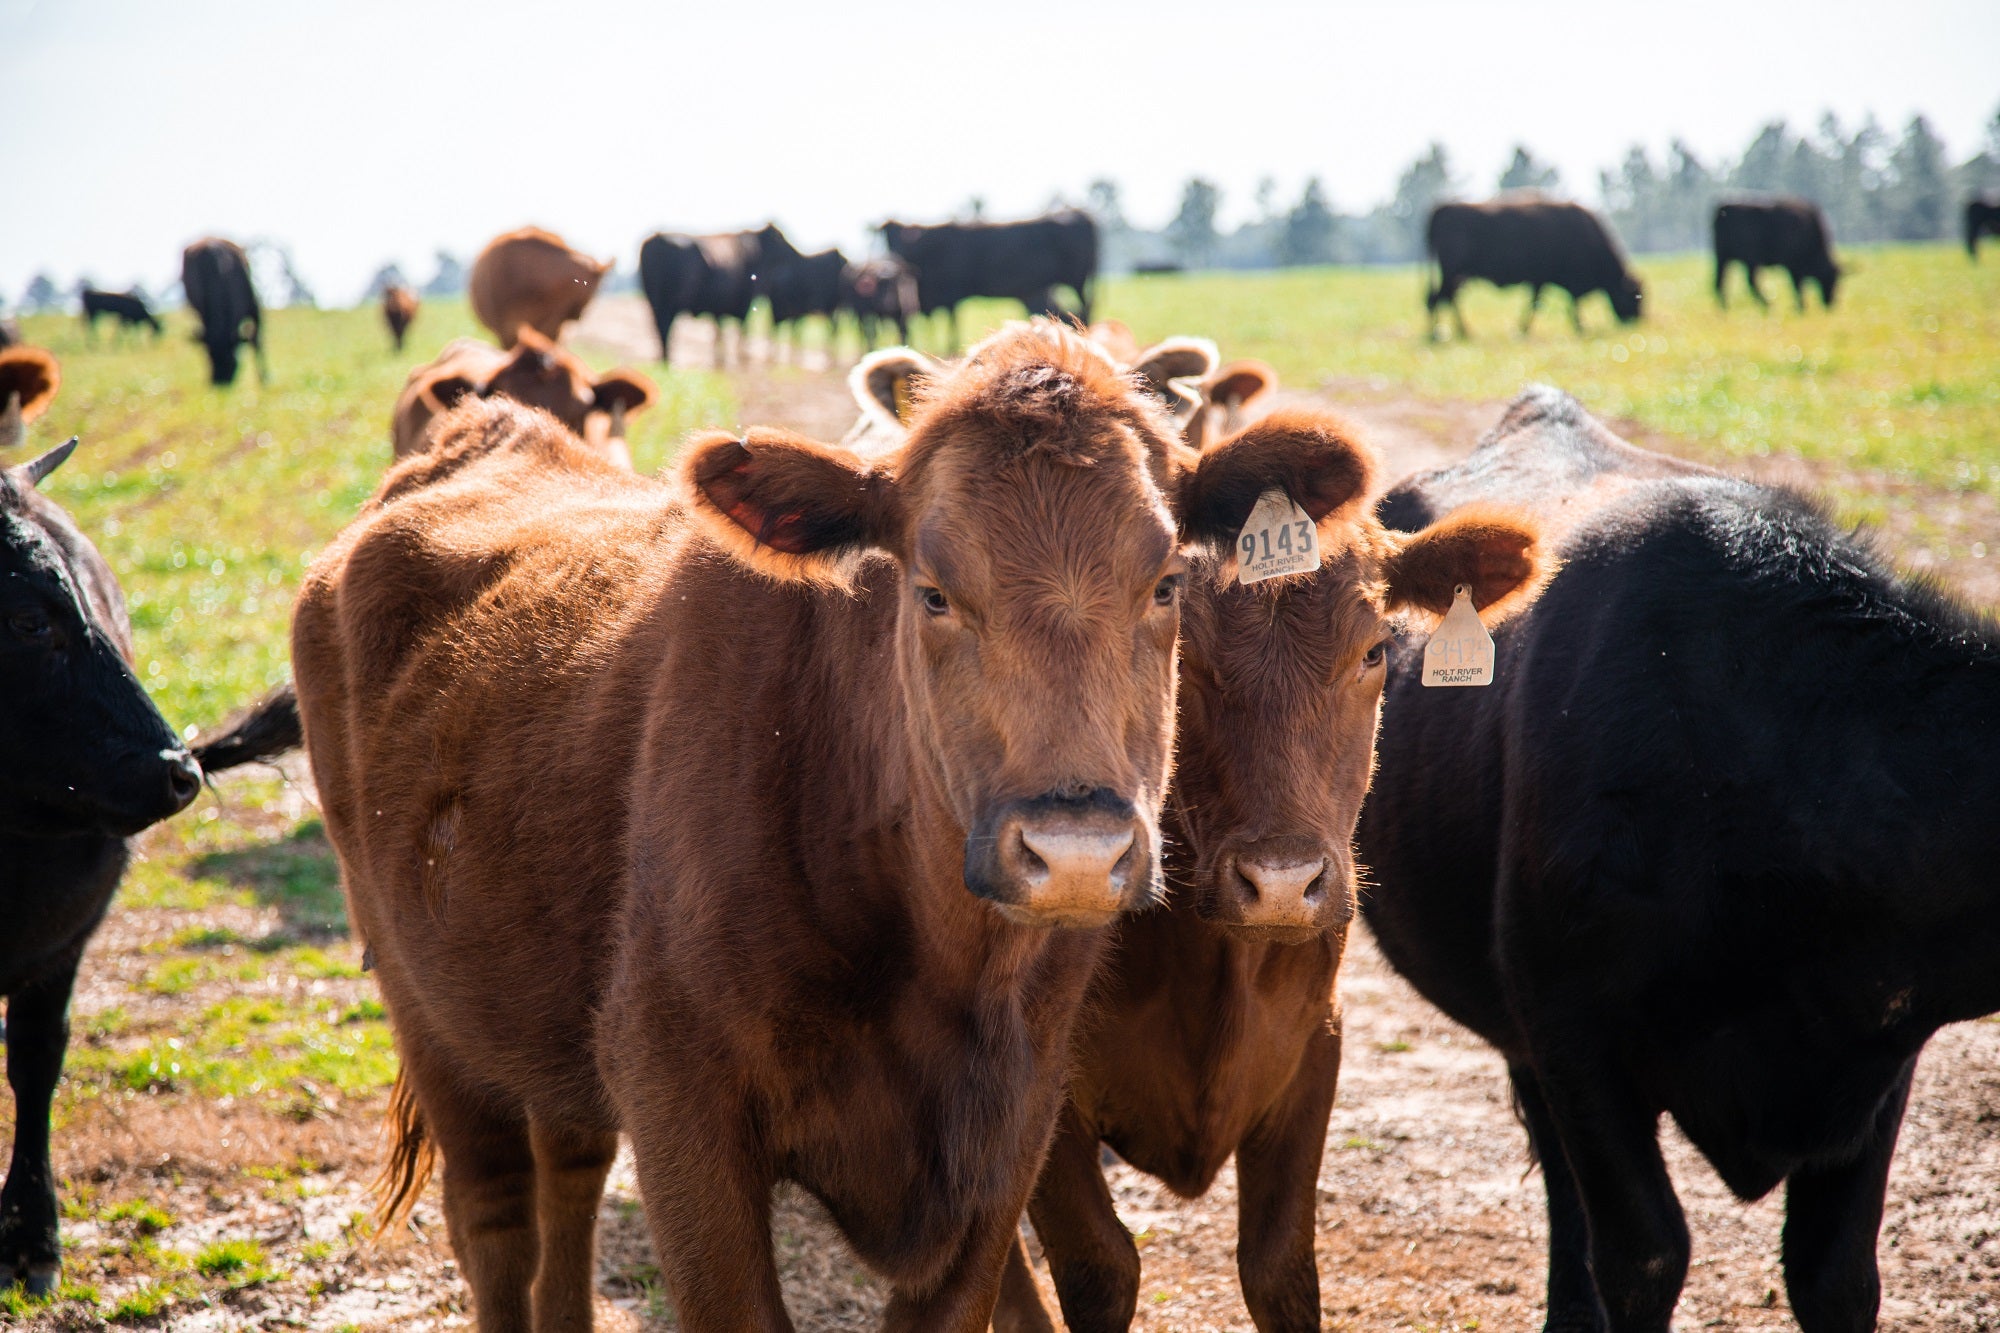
top-left (680, 324), bottom-right (1184, 925)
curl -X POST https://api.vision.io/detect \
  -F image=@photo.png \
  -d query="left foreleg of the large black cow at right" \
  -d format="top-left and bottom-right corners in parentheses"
top-left (1538, 1033), bottom-right (1688, 1333)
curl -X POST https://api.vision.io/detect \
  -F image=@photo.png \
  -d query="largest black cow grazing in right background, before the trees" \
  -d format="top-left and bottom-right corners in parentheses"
top-left (1424, 192), bottom-right (1644, 338)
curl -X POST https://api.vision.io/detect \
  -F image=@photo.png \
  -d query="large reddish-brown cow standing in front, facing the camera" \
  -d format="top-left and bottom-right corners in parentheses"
top-left (294, 328), bottom-right (1360, 1333)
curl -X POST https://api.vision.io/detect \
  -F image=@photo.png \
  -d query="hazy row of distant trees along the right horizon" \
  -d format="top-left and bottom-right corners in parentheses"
top-left (1082, 112), bottom-right (2000, 272)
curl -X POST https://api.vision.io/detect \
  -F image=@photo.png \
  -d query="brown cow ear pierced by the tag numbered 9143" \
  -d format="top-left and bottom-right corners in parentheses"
top-left (1176, 410), bottom-right (1374, 542)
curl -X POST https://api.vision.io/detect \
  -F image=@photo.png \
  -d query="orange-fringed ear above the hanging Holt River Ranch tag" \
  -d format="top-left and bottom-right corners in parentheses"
top-left (1382, 506), bottom-right (1554, 624)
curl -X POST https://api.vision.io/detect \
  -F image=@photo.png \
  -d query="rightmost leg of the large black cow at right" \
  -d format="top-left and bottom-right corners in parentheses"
top-left (1784, 1063), bottom-right (1916, 1333)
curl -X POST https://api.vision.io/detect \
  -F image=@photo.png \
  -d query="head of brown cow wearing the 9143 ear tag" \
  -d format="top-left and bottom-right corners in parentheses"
top-left (1172, 410), bottom-right (1546, 941)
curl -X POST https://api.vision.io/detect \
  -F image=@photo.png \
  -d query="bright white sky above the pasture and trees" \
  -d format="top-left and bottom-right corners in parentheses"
top-left (0, 0), bottom-right (2000, 302)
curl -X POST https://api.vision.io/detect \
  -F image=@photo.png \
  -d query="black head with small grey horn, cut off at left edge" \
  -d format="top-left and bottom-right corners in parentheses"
top-left (0, 440), bottom-right (202, 837)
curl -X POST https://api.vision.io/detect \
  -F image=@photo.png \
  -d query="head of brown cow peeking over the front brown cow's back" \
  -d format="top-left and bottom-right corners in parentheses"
top-left (420, 324), bottom-right (658, 466)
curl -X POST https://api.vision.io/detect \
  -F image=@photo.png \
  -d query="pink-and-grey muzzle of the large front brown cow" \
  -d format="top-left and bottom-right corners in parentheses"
top-left (966, 787), bottom-right (1152, 927)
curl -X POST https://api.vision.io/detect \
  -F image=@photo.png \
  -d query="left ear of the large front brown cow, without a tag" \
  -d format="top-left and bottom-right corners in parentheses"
top-left (678, 428), bottom-right (898, 584)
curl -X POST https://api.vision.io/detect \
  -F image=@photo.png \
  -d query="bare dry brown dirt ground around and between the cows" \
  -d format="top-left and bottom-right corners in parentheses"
top-left (15, 314), bottom-right (2000, 1333)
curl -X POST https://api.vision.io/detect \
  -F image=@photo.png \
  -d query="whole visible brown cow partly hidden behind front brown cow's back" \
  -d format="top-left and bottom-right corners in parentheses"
top-left (390, 326), bottom-right (660, 470)
